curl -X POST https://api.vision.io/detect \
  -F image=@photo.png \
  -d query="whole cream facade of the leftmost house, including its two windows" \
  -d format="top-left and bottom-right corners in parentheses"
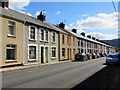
top-left (0, 16), bottom-right (23, 67)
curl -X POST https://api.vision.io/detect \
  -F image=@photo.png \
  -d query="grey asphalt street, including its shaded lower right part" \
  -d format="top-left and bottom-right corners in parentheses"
top-left (2, 58), bottom-right (120, 89)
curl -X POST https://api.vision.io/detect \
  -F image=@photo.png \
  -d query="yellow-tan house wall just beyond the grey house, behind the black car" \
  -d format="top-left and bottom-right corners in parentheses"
top-left (60, 33), bottom-right (77, 60)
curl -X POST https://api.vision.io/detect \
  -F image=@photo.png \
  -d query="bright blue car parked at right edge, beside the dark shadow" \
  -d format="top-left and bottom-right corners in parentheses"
top-left (106, 54), bottom-right (120, 64)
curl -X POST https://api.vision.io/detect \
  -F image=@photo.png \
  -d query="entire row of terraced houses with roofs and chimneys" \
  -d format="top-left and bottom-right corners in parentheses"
top-left (0, 2), bottom-right (115, 67)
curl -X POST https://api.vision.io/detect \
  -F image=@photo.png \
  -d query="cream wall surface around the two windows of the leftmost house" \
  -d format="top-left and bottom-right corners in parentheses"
top-left (0, 17), bottom-right (23, 66)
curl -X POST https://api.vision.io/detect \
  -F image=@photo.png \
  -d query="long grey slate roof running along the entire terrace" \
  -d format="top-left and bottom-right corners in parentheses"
top-left (0, 7), bottom-right (112, 46)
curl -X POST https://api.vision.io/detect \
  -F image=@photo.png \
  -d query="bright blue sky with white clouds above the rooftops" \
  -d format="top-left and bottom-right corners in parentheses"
top-left (10, 0), bottom-right (118, 40)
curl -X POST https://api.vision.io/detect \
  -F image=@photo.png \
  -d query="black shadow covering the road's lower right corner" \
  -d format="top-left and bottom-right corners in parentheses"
top-left (71, 65), bottom-right (120, 90)
